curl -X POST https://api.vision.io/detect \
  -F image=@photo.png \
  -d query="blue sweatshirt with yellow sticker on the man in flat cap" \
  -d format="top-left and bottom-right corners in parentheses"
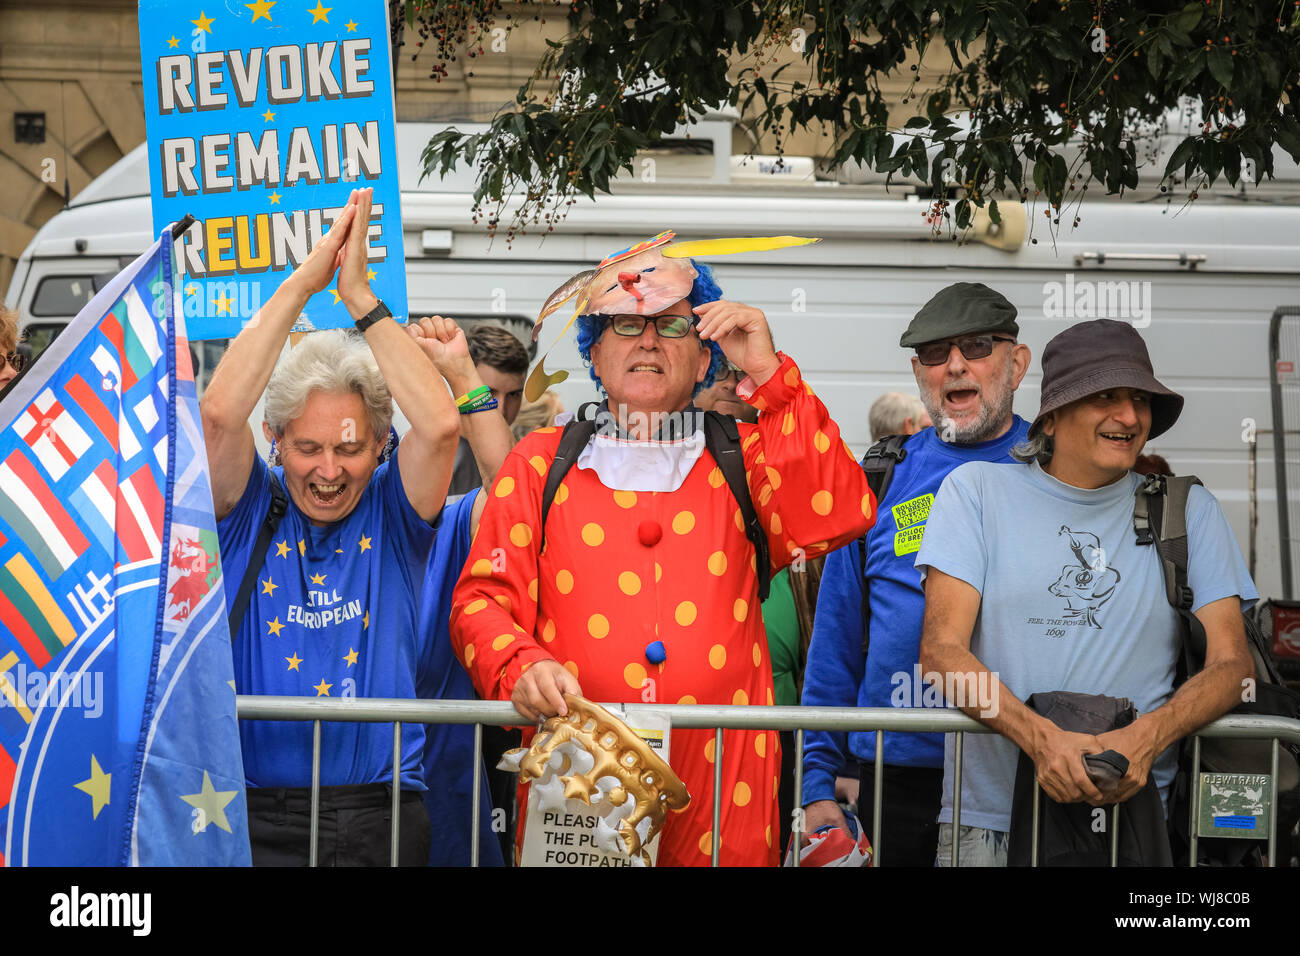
top-left (802, 416), bottom-right (1028, 804)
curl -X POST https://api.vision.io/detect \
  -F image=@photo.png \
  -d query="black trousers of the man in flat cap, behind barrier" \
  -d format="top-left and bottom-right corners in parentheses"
top-left (858, 761), bottom-right (944, 866)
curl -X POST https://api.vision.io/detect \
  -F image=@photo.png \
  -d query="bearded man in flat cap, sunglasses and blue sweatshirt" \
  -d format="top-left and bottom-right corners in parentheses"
top-left (803, 282), bottom-right (1030, 866)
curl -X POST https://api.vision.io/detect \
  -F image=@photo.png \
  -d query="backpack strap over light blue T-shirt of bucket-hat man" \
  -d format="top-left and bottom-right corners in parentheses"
top-left (1134, 475), bottom-right (1205, 676)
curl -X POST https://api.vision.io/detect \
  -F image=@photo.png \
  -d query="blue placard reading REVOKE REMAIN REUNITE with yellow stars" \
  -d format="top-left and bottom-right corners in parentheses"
top-left (139, 0), bottom-right (407, 339)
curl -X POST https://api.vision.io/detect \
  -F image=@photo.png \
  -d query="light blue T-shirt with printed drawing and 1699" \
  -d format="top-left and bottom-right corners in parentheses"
top-left (917, 462), bottom-right (1258, 831)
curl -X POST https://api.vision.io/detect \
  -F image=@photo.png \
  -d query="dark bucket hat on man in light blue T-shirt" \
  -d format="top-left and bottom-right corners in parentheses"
top-left (1030, 319), bottom-right (1183, 438)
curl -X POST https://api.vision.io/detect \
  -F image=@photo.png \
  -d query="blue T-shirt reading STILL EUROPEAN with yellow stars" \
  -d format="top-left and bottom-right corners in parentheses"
top-left (217, 455), bottom-right (436, 790)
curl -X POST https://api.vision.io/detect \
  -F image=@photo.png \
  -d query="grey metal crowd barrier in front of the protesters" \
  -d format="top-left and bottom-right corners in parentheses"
top-left (235, 695), bottom-right (1300, 866)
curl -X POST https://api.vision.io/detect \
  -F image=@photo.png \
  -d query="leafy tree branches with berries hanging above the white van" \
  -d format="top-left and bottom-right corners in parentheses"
top-left (407, 0), bottom-right (1300, 239)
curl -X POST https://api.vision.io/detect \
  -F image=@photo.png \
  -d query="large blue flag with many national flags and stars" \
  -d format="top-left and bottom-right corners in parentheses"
top-left (0, 232), bottom-right (250, 866)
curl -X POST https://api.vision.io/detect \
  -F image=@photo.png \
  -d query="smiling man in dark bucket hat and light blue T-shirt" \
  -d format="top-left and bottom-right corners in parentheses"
top-left (917, 319), bottom-right (1257, 866)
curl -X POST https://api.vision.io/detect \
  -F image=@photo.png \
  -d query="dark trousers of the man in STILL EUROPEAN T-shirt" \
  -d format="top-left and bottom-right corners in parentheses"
top-left (248, 783), bottom-right (433, 866)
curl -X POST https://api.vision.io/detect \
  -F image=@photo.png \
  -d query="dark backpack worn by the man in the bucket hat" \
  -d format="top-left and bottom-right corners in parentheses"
top-left (1134, 475), bottom-right (1300, 866)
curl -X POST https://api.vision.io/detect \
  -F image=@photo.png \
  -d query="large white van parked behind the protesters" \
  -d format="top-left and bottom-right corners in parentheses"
top-left (7, 122), bottom-right (1300, 594)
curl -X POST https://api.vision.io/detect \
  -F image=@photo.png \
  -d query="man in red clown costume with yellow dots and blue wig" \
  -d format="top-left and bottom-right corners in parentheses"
top-left (451, 233), bottom-right (875, 866)
